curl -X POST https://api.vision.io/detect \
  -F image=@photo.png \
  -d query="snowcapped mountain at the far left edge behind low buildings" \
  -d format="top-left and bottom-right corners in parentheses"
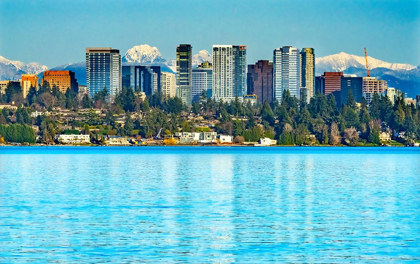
top-left (0, 56), bottom-right (48, 80)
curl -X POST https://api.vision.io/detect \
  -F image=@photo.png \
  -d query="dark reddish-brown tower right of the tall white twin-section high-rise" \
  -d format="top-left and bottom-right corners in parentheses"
top-left (247, 60), bottom-right (273, 103)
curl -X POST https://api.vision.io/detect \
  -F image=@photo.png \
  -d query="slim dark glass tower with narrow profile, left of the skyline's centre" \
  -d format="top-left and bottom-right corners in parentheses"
top-left (176, 44), bottom-right (192, 105)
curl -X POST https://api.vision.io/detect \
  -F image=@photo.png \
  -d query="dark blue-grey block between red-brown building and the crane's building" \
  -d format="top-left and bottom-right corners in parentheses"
top-left (336, 76), bottom-right (363, 107)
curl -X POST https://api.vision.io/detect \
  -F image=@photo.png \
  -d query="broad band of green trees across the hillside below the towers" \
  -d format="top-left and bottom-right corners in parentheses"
top-left (0, 81), bottom-right (420, 145)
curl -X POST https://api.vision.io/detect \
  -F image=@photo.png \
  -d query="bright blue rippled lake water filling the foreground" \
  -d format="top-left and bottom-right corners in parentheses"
top-left (0, 147), bottom-right (420, 263)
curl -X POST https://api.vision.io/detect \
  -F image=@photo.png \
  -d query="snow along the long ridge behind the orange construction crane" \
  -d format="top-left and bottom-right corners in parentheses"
top-left (315, 52), bottom-right (416, 74)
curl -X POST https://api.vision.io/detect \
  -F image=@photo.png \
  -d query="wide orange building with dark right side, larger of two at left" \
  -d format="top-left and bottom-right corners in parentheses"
top-left (41, 71), bottom-right (79, 93)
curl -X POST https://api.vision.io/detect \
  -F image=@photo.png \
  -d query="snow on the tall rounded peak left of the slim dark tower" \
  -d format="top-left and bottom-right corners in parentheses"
top-left (122, 44), bottom-right (166, 64)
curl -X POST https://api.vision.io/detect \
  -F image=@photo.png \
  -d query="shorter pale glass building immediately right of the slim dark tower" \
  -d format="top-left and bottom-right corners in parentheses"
top-left (192, 61), bottom-right (213, 102)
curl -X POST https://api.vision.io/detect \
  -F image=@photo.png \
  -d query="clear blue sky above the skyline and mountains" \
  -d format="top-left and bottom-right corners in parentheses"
top-left (0, 0), bottom-right (420, 67)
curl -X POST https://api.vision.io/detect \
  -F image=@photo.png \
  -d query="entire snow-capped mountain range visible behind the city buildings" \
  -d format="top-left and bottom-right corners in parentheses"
top-left (0, 44), bottom-right (420, 97)
